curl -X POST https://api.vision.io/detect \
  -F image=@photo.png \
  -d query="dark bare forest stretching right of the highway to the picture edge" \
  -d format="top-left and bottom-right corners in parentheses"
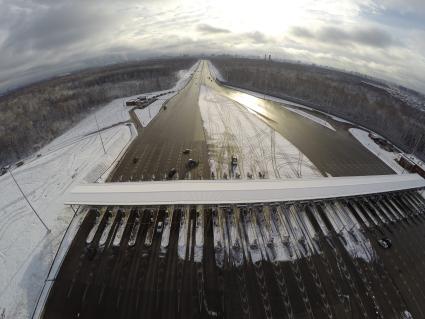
top-left (212, 57), bottom-right (425, 160)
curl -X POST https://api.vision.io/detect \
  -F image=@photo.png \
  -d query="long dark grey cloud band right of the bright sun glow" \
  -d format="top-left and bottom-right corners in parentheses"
top-left (291, 26), bottom-right (395, 48)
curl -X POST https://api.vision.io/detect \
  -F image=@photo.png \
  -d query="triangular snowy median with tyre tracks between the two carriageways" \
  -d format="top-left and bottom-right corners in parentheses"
top-left (199, 86), bottom-right (322, 178)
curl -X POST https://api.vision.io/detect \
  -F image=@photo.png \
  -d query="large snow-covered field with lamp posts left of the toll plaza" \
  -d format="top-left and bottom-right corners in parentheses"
top-left (0, 94), bottom-right (137, 319)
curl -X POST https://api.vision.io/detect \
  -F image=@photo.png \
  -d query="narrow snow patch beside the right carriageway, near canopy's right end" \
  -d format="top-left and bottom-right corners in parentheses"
top-left (349, 128), bottom-right (409, 174)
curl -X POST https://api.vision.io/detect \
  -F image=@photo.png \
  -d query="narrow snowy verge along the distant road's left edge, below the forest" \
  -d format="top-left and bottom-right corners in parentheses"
top-left (134, 62), bottom-right (200, 127)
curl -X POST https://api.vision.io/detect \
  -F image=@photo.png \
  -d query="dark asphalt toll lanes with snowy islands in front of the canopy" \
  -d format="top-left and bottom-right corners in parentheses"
top-left (43, 192), bottom-right (425, 319)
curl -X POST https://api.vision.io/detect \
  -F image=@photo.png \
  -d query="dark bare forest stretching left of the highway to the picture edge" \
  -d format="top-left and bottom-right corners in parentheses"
top-left (0, 58), bottom-right (195, 166)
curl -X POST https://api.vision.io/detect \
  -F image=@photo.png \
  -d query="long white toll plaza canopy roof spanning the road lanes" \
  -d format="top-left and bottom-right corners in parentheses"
top-left (65, 174), bottom-right (425, 205)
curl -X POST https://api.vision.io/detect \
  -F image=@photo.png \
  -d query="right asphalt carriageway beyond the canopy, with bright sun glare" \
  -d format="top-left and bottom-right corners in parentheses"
top-left (204, 63), bottom-right (394, 176)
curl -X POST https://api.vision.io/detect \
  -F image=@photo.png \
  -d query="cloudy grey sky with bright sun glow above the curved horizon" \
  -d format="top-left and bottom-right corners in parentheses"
top-left (0, 0), bottom-right (425, 93)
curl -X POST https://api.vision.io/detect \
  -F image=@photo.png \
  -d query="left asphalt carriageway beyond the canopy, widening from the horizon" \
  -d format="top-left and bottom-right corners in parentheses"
top-left (110, 62), bottom-right (210, 182)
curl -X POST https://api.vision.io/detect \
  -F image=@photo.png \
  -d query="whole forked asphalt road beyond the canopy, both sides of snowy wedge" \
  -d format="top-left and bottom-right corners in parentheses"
top-left (110, 61), bottom-right (393, 182)
